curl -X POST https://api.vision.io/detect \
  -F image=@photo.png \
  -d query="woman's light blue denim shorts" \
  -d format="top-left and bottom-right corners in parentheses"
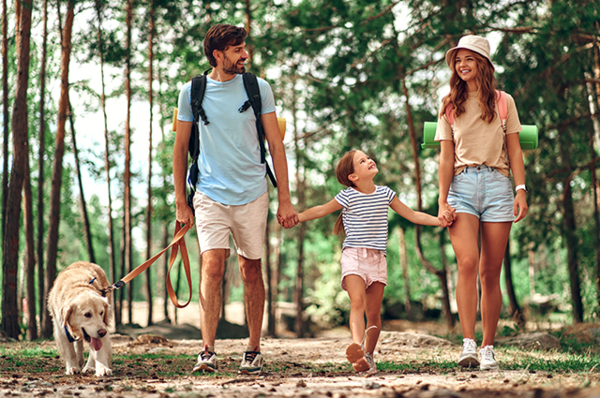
top-left (448, 165), bottom-right (515, 222)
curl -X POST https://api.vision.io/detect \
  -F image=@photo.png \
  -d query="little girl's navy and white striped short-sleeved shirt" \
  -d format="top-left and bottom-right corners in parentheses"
top-left (335, 186), bottom-right (396, 254)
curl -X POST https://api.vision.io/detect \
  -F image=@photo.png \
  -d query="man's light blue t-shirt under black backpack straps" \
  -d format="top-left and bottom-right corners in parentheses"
top-left (177, 75), bottom-right (275, 205)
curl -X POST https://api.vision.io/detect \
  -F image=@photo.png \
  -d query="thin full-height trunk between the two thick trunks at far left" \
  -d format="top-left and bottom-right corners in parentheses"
top-left (36, 0), bottom-right (48, 332)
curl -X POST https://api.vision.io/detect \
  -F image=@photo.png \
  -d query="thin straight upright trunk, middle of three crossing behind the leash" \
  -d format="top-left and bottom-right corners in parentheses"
top-left (123, 0), bottom-right (135, 324)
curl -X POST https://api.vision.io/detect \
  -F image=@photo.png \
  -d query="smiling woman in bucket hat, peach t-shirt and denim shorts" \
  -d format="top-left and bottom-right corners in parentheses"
top-left (435, 36), bottom-right (527, 370)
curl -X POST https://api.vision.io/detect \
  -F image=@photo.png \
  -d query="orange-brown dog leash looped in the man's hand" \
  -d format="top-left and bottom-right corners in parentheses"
top-left (106, 221), bottom-right (192, 308)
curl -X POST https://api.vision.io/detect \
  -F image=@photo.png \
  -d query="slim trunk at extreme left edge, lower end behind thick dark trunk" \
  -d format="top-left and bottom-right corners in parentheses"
top-left (0, 0), bottom-right (10, 240)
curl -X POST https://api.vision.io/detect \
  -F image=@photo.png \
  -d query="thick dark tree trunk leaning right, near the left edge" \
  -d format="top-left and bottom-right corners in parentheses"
top-left (2, 0), bottom-right (32, 338)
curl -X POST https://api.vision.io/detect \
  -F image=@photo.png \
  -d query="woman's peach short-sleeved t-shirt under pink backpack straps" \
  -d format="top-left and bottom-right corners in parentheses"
top-left (435, 92), bottom-right (522, 177)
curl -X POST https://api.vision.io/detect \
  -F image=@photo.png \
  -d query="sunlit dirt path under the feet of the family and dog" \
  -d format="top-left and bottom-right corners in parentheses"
top-left (0, 332), bottom-right (600, 398)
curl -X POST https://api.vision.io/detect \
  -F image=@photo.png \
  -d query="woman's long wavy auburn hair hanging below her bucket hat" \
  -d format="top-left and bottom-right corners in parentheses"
top-left (439, 50), bottom-right (498, 123)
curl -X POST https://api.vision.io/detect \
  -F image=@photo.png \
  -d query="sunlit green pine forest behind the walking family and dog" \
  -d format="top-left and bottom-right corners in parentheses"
top-left (1, 0), bottom-right (600, 340)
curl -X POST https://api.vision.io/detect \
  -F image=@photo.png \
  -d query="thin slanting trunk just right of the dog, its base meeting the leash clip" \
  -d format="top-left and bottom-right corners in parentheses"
top-left (96, 1), bottom-right (121, 326)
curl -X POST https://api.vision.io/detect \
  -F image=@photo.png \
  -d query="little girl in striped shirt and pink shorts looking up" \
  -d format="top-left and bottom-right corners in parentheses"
top-left (298, 150), bottom-right (454, 374)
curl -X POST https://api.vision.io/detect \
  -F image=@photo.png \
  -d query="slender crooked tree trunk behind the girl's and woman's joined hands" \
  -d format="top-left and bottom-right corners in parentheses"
top-left (401, 78), bottom-right (454, 330)
